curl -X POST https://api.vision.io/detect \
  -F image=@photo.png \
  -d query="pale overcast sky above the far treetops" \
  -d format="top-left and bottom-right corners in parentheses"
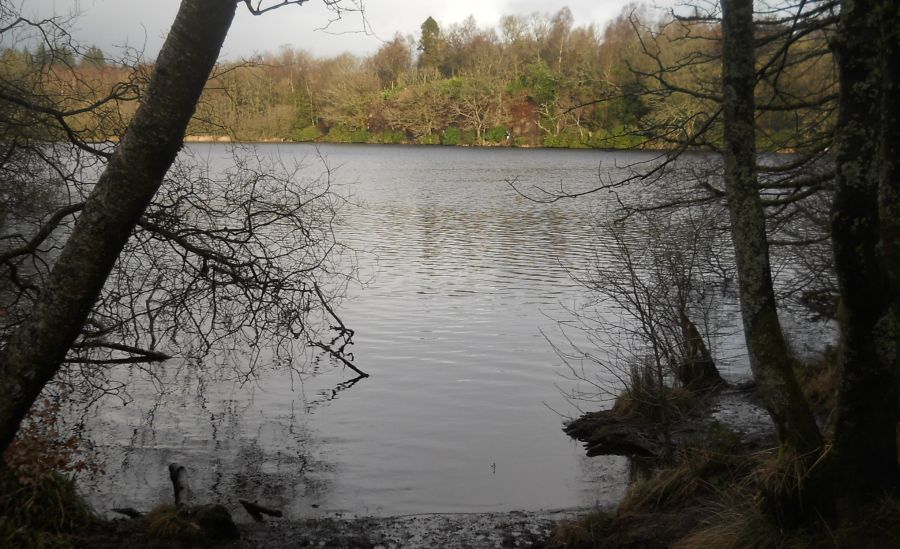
top-left (26, 0), bottom-right (626, 59)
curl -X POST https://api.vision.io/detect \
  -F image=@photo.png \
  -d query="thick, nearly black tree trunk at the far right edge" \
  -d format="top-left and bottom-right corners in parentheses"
top-left (831, 0), bottom-right (898, 506)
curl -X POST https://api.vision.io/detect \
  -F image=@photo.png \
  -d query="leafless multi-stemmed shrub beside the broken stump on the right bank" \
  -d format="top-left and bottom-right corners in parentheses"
top-left (551, 203), bottom-right (730, 456)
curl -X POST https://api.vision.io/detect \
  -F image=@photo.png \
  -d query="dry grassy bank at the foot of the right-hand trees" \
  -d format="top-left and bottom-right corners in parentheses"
top-left (548, 350), bottom-right (900, 549)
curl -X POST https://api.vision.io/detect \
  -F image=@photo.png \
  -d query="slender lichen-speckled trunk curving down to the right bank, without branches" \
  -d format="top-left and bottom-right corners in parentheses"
top-left (722, 0), bottom-right (821, 454)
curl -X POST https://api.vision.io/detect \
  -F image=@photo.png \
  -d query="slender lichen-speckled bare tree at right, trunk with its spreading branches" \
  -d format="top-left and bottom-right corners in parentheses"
top-left (523, 1), bottom-right (836, 454)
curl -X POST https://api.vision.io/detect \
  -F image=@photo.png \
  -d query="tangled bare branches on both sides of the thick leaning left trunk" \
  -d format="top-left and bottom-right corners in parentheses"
top-left (0, 22), bottom-right (363, 402)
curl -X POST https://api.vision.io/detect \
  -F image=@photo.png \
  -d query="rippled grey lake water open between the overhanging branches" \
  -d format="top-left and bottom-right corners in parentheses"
top-left (81, 145), bottom-right (720, 517)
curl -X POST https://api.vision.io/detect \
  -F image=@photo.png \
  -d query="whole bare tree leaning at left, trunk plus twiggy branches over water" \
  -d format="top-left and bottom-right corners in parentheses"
top-left (0, 0), bottom-right (366, 458)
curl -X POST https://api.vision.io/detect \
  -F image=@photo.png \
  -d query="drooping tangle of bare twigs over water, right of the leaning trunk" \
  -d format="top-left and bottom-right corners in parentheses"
top-left (65, 144), bottom-right (362, 373)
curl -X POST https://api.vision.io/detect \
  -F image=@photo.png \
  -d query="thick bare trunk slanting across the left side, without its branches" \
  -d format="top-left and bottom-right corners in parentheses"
top-left (0, 0), bottom-right (237, 455)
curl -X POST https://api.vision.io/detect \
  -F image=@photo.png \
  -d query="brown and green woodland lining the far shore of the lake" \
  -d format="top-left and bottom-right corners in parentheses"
top-left (0, 5), bottom-right (836, 151)
